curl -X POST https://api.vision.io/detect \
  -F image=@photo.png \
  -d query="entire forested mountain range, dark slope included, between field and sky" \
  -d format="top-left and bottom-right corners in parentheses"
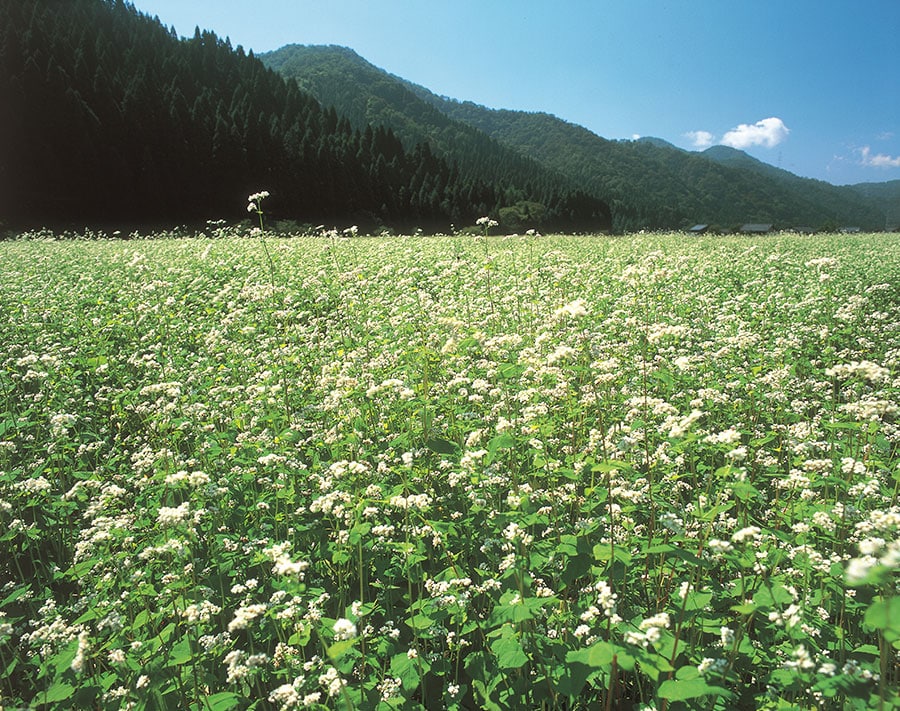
top-left (0, 0), bottom-right (888, 231)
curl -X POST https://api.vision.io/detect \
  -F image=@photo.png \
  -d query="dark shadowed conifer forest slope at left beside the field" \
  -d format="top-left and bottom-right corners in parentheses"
top-left (0, 0), bottom-right (610, 231)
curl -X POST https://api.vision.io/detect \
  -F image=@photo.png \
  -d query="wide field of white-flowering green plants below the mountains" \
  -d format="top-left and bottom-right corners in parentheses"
top-left (0, 231), bottom-right (900, 711)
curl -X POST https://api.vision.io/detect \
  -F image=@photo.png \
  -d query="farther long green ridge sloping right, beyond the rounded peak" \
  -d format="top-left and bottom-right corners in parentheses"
top-left (417, 88), bottom-right (885, 229)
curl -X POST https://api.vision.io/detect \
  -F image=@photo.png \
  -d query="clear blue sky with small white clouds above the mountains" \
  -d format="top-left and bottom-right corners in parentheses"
top-left (128, 0), bottom-right (900, 185)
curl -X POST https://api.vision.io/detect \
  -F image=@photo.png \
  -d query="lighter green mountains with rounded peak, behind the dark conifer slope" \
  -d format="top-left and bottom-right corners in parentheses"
top-left (260, 45), bottom-right (885, 230)
